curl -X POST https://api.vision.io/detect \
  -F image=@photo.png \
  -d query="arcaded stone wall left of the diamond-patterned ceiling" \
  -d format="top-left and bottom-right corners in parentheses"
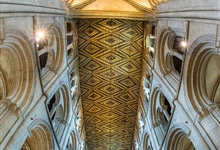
top-left (0, 0), bottom-right (85, 150)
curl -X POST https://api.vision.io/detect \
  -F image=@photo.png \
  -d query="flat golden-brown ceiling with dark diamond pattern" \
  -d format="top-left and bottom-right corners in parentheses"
top-left (78, 19), bottom-right (143, 150)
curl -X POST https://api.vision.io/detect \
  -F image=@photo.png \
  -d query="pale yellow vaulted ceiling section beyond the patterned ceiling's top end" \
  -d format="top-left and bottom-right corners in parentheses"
top-left (66, 0), bottom-right (167, 20)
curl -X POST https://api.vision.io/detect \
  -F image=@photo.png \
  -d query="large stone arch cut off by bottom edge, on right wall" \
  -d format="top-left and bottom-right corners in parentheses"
top-left (164, 124), bottom-right (195, 150)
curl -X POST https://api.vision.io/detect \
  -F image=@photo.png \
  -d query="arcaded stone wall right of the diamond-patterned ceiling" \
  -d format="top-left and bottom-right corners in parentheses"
top-left (135, 0), bottom-right (220, 150)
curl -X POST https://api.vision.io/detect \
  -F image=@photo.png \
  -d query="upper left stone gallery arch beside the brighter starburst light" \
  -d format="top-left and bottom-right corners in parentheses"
top-left (36, 23), bottom-right (65, 75)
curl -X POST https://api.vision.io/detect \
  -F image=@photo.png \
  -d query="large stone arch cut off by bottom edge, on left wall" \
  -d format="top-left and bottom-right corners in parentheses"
top-left (21, 119), bottom-right (53, 150)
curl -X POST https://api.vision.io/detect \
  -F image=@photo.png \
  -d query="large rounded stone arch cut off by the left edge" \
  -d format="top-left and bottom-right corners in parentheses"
top-left (0, 29), bottom-right (36, 114)
